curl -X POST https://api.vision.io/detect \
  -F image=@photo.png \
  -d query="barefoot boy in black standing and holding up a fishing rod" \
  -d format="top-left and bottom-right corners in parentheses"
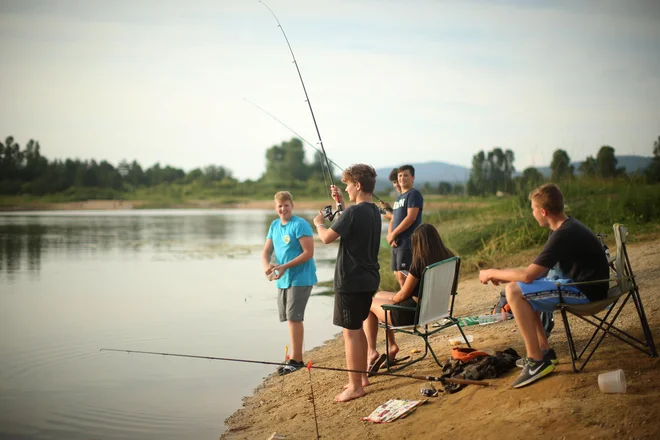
top-left (314, 164), bottom-right (381, 402)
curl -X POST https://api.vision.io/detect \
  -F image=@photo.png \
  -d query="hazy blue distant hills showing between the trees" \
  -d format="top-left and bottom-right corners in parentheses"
top-left (376, 155), bottom-right (653, 191)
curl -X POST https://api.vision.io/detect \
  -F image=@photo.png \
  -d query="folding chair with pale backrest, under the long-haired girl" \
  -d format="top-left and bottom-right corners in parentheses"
top-left (382, 257), bottom-right (470, 372)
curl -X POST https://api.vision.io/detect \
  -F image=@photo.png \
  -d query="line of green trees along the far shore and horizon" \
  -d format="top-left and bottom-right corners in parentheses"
top-left (0, 136), bottom-right (660, 196)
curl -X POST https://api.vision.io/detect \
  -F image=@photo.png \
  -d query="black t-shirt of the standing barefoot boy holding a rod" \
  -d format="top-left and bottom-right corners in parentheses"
top-left (330, 202), bottom-right (381, 293)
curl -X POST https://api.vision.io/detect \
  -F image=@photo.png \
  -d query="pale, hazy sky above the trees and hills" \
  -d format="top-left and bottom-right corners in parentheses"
top-left (0, 0), bottom-right (660, 180)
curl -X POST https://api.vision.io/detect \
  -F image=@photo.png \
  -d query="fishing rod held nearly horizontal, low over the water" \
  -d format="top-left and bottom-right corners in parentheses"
top-left (100, 348), bottom-right (489, 387)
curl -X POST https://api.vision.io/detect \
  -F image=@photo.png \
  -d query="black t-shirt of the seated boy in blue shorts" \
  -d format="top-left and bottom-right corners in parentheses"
top-left (534, 217), bottom-right (610, 301)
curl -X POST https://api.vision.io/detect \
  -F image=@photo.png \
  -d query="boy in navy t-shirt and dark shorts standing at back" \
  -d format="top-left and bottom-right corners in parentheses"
top-left (387, 165), bottom-right (424, 287)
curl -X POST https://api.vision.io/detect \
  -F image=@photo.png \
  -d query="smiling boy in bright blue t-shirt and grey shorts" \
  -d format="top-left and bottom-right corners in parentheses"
top-left (261, 191), bottom-right (317, 375)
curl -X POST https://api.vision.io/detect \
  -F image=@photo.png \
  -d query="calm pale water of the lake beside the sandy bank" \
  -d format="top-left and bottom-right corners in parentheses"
top-left (0, 210), bottom-right (340, 440)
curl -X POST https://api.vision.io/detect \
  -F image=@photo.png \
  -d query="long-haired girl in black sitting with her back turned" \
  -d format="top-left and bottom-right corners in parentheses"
top-left (364, 223), bottom-right (454, 373)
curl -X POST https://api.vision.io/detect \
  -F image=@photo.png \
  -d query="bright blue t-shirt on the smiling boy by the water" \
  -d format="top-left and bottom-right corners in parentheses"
top-left (266, 215), bottom-right (317, 289)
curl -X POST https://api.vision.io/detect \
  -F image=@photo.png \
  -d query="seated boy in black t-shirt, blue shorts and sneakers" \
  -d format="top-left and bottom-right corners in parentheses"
top-left (479, 183), bottom-right (609, 388)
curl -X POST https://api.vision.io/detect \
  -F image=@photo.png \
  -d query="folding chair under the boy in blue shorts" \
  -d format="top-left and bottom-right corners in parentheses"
top-left (557, 223), bottom-right (658, 373)
